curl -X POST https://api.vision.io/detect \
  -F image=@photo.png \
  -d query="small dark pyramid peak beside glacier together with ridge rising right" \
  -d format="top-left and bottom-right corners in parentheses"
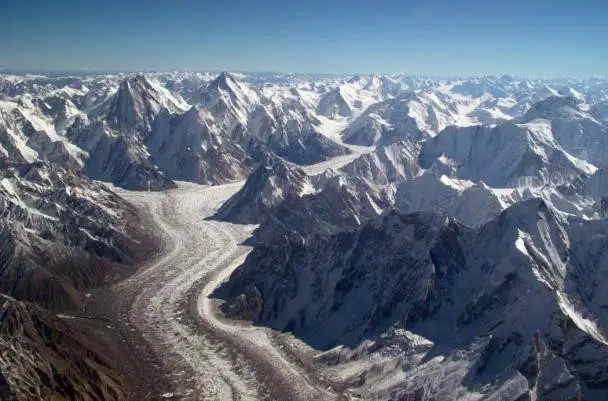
top-left (216, 141), bottom-right (420, 242)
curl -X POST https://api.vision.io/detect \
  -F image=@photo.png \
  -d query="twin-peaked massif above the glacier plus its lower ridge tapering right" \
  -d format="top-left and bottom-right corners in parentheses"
top-left (61, 73), bottom-right (349, 190)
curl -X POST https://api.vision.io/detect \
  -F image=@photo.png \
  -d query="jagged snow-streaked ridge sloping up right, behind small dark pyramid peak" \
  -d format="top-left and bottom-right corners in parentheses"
top-left (240, 141), bottom-right (420, 243)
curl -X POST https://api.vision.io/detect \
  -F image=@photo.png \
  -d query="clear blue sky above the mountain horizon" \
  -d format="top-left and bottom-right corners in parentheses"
top-left (0, 0), bottom-right (608, 77)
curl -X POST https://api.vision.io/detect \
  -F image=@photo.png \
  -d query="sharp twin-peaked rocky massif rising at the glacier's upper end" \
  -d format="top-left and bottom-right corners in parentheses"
top-left (69, 74), bottom-right (262, 190)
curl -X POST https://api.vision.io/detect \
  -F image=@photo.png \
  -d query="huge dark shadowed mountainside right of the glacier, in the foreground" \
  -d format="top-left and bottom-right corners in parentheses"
top-left (218, 199), bottom-right (608, 401)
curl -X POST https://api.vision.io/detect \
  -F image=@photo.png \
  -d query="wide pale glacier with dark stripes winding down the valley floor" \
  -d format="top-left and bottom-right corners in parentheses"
top-left (93, 182), bottom-right (343, 401)
